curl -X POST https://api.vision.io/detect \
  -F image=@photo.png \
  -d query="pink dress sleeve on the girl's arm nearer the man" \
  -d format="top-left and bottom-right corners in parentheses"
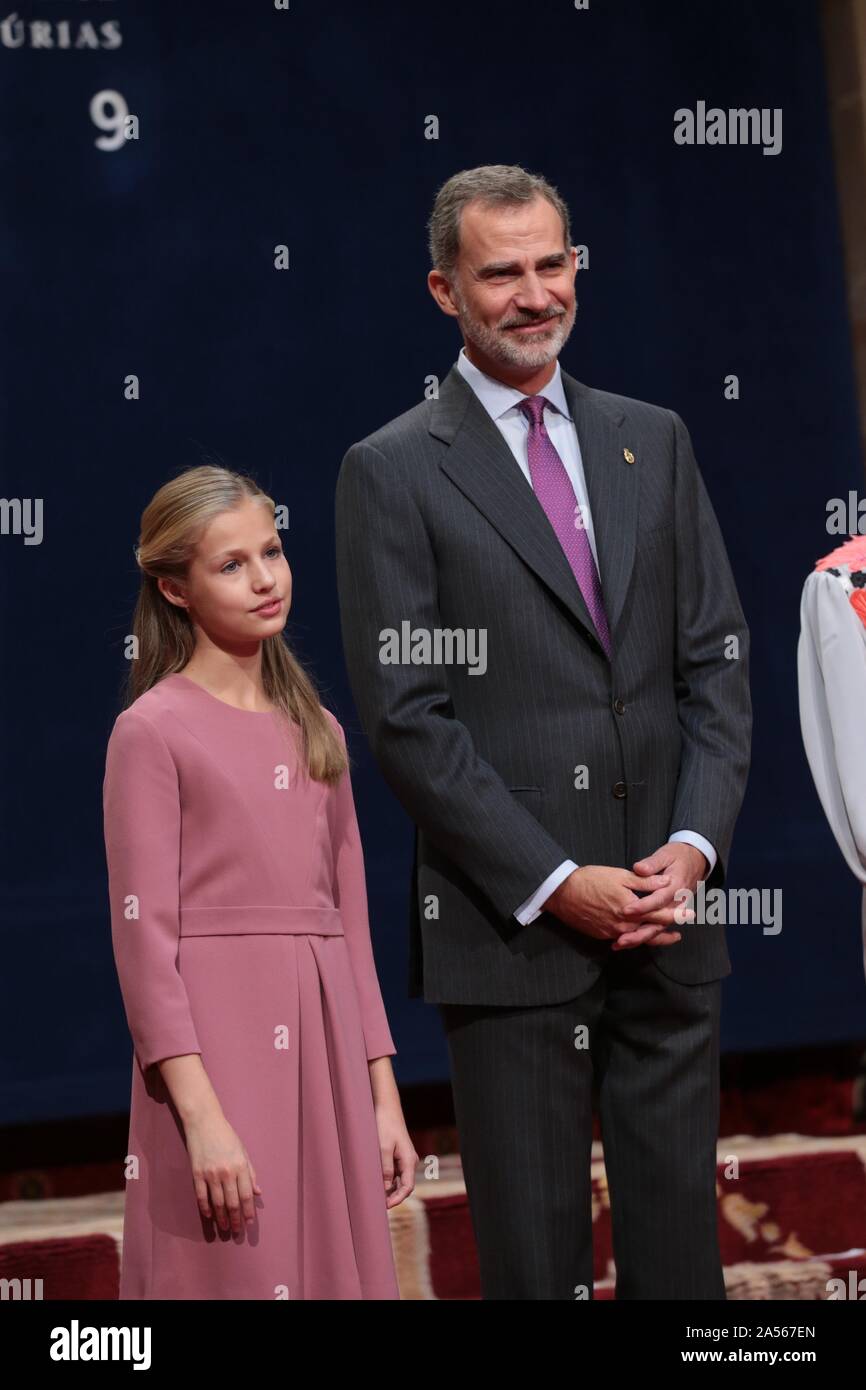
top-left (332, 721), bottom-right (396, 1061)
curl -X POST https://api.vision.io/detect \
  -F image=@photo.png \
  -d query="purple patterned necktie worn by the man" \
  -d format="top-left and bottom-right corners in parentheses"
top-left (518, 396), bottom-right (610, 660)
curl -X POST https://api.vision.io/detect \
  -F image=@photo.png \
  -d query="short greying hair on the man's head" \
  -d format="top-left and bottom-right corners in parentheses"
top-left (427, 164), bottom-right (571, 279)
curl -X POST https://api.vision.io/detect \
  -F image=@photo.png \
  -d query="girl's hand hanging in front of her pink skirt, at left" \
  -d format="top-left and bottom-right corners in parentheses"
top-left (185, 1111), bottom-right (261, 1234)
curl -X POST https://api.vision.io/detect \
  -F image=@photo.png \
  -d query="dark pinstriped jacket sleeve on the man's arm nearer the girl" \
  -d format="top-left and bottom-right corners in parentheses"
top-left (335, 442), bottom-right (569, 919)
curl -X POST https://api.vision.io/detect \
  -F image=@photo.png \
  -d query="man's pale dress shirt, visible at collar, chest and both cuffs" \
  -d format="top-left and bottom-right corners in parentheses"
top-left (457, 348), bottom-right (717, 926)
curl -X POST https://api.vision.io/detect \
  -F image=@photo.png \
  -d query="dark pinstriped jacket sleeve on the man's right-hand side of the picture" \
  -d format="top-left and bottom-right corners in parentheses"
top-left (669, 411), bottom-right (752, 887)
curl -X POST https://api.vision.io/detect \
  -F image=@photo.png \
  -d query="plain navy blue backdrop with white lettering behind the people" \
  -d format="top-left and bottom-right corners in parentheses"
top-left (0, 0), bottom-right (866, 1120)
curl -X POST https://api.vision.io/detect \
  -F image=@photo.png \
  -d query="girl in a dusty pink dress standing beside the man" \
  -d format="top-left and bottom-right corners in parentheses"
top-left (103, 466), bottom-right (418, 1300)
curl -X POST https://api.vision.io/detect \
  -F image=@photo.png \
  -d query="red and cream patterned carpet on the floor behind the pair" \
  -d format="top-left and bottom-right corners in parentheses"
top-left (0, 1134), bottom-right (866, 1301)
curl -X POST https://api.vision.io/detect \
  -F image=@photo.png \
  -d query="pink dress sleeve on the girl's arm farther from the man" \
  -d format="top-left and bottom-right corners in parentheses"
top-left (103, 710), bottom-right (202, 1070)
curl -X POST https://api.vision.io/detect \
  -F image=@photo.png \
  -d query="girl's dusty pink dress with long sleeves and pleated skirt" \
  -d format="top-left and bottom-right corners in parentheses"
top-left (103, 674), bottom-right (399, 1300)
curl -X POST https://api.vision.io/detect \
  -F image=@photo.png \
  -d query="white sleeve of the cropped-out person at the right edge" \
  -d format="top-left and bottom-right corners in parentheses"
top-left (796, 566), bottom-right (866, 972)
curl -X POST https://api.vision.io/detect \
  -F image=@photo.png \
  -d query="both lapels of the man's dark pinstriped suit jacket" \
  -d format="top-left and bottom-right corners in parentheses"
top-left (430, 367), bottom-right (639, 655)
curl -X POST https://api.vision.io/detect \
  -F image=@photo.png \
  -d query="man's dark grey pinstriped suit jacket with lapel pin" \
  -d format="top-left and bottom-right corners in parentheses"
top-left (336, 366), bottom-right (752, 1005)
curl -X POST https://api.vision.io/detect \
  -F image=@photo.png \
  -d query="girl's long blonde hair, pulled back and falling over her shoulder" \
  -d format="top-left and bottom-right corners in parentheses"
top-left (124, 464), bottom-right (348, 783)
